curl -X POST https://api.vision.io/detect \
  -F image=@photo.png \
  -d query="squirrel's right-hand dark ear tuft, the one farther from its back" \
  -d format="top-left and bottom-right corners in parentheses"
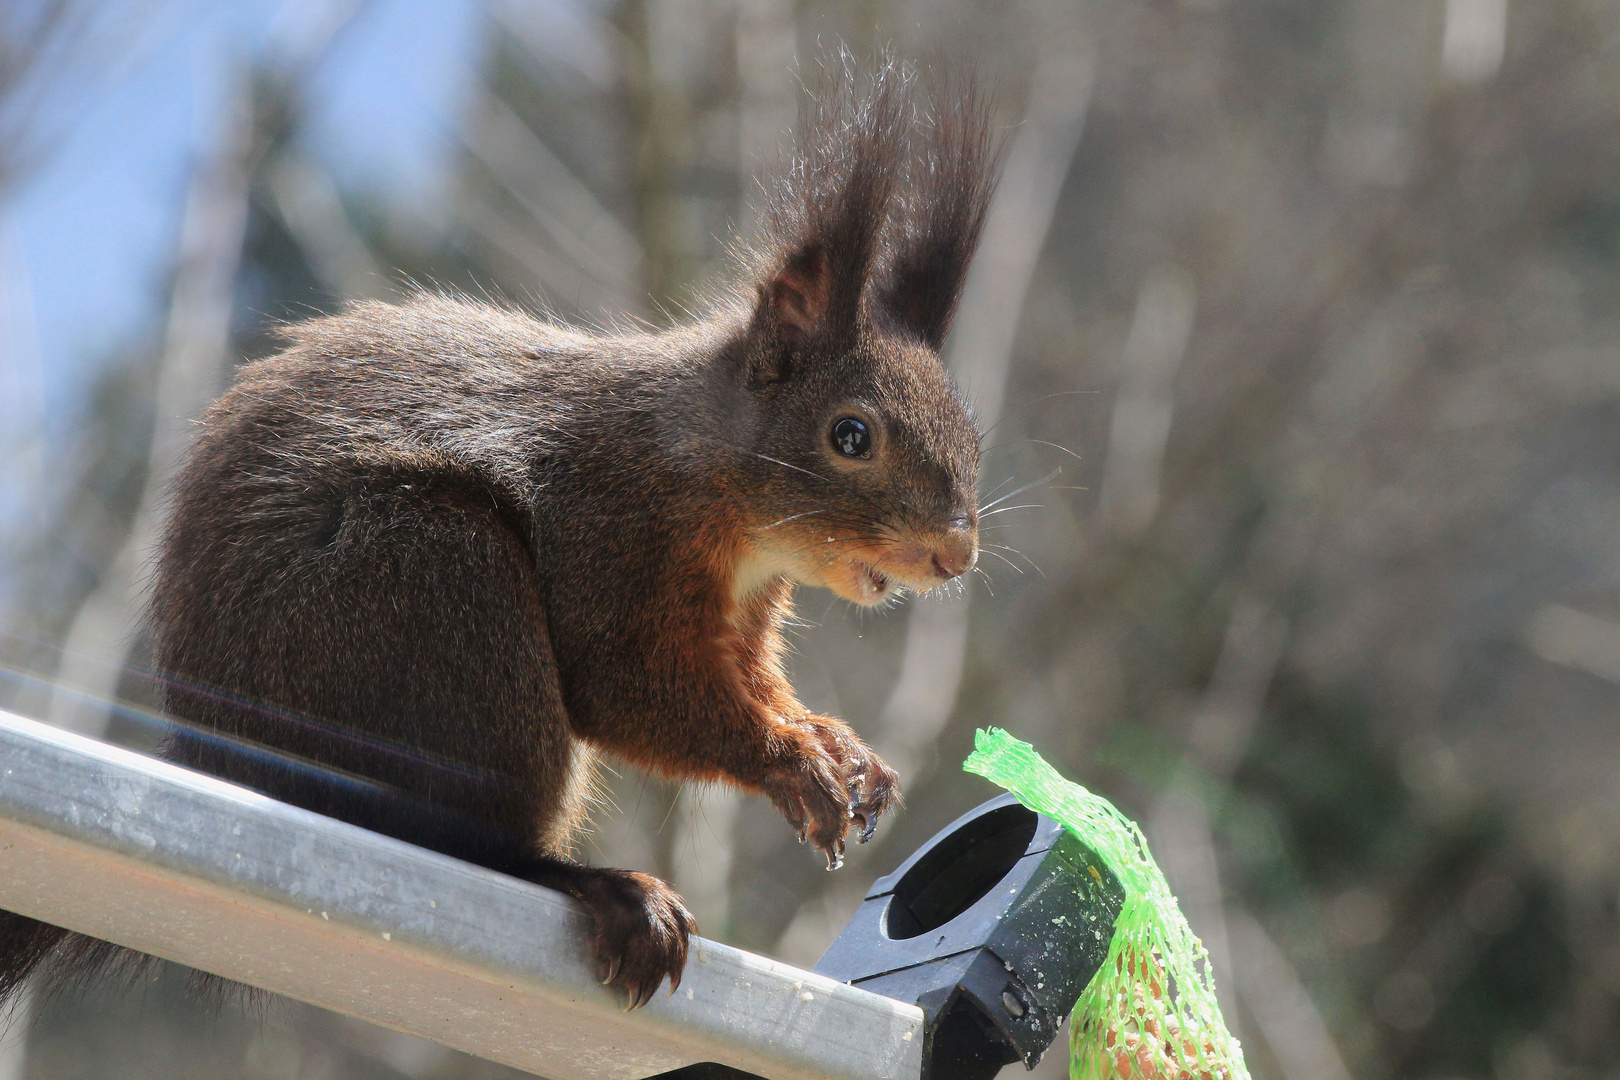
top-left (878, 76), bottom-right (1001, 350)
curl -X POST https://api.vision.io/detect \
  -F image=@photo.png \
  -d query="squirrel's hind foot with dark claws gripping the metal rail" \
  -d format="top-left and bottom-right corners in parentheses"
top-left (580, 870), bottom-right (697, 1009)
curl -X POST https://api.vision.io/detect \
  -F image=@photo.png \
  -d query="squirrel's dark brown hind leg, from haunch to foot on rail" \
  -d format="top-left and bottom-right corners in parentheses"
top-left (154, 471), bottom-right (693, 1006)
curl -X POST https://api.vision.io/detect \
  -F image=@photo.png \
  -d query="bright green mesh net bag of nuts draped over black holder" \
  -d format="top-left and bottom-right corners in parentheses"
top-left (962, 727), bottom-right (1249, 1080)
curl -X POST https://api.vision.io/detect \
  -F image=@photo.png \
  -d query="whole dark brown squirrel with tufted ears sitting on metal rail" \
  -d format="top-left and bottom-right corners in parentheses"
top-left (0, 63), bottom-right (995, 1007)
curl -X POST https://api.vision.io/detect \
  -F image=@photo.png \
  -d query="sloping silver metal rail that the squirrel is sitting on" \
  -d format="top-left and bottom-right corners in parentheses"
top-left (0, 711), bottom-right (923, 1080)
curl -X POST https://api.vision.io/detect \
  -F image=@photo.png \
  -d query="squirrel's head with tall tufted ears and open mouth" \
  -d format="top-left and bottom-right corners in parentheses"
top-left (734, 65), bottom-right (995, 606)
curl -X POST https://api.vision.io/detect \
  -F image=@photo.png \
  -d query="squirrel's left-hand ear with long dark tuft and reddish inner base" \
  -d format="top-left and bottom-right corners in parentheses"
top-left (750, 50), bottom-right (910, 350)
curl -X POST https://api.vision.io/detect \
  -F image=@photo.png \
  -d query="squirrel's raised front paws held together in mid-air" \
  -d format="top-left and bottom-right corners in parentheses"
top-left (771, 716), bottom-right (901, 870)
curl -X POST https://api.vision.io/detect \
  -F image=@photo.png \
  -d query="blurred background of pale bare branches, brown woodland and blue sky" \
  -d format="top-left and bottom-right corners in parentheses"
top-left (0, 0), bottom-right (1620, 1080)
